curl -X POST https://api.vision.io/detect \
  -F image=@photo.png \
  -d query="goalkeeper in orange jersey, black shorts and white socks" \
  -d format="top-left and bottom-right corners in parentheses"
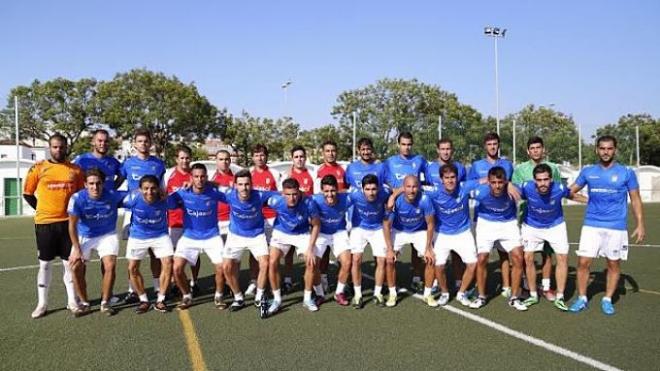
top-left (23, 134), bottom-right (84, 318)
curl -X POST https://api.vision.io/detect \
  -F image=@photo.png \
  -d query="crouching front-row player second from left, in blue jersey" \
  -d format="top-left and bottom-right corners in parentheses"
top-left (123, 176), bottom-right (174, 314)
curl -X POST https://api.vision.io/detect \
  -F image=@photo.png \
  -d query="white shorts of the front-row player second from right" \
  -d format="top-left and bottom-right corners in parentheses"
top-left (476, 218), bottom-right (522, 254)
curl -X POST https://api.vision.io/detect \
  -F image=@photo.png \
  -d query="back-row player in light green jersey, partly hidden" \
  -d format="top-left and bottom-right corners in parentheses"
top-left (511, 137), bottom-right (563, 301)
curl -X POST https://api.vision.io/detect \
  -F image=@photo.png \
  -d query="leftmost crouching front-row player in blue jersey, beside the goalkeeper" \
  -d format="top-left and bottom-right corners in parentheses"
top-left (67, 169), bottom-right (124, 316)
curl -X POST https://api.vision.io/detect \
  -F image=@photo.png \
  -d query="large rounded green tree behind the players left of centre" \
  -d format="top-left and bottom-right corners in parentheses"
top-left (98, 69), bottom-right (222, 155)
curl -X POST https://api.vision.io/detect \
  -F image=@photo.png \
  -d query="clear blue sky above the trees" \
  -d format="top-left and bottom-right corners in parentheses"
top-left (0, 0), bottom-right (660, 137)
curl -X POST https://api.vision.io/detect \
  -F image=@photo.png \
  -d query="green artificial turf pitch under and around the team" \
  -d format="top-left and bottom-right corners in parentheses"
top-left (0, 204), bottom-right (660, 370)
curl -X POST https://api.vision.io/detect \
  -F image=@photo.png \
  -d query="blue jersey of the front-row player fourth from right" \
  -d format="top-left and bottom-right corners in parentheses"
top-left (389, 192), bottom-right (434, 232)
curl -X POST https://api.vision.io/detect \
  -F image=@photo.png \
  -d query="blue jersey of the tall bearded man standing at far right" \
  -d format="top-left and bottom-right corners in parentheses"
top-left (575, 163), bottom-right (639, 231)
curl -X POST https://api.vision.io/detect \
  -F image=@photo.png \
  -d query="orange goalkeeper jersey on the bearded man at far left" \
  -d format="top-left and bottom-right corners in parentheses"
top-left (23, 161), bottom-right (84, 224)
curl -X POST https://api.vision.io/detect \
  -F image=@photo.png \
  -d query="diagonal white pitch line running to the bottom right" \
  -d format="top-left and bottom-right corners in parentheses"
top-left (362, 273), bottom-right (621, 371)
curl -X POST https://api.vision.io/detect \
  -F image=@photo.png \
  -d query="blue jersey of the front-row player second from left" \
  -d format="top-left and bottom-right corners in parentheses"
top-left (123, 191), bottom-right (167, 240)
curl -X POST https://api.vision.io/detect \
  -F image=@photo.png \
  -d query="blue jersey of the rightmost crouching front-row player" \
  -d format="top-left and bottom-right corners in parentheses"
top-left (520, 181), bottom-right (571, 228)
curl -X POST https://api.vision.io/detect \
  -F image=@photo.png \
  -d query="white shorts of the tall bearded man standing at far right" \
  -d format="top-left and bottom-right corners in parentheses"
top-left (576, 225), bottom-right (628, 260)
